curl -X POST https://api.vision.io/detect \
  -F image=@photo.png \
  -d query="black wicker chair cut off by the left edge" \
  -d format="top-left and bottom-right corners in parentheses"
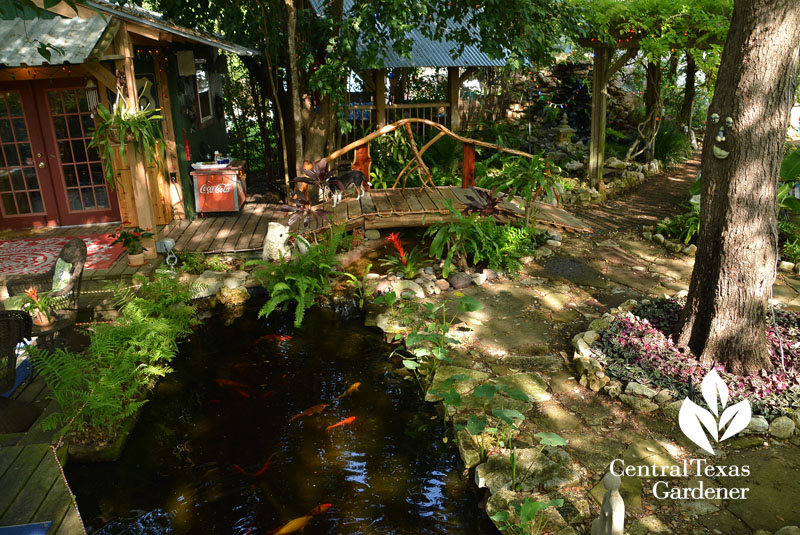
top-left (0, 310), bottom-right (41, 433)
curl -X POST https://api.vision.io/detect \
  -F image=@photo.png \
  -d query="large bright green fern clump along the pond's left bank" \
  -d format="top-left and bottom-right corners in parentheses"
top-left (30, 274), bottom-right (197, 441)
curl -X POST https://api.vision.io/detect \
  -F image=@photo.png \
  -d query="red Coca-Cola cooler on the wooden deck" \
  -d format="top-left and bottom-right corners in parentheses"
top-left (190, 160), bottom-right (246, 214)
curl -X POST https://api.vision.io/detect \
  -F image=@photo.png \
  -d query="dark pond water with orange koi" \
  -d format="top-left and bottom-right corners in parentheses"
top-left (67, 307), bottom-right (496, 535)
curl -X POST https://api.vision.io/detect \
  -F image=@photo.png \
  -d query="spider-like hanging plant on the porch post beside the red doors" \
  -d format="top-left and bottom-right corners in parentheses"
top-left (88, 82), bottom-right (166, 189)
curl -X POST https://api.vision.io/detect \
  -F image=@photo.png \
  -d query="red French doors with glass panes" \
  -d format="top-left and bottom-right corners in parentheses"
top-left (0, 79), bottom-right (119, 228)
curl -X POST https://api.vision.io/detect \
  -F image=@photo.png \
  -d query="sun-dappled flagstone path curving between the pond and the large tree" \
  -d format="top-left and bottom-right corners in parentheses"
top-left (376, 160), bottom-right (800, 535)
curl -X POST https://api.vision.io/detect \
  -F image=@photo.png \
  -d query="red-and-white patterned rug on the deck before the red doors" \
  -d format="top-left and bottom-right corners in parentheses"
top-left (0, 234), bottom-right (125, 275)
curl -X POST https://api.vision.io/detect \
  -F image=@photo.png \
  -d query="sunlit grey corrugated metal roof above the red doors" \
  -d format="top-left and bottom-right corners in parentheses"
top-left (0, 17), bottom-right (108, 67)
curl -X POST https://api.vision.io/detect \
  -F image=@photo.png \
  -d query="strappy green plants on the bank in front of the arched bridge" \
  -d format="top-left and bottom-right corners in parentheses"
top-left (425, 201), bottom-right (540, 278)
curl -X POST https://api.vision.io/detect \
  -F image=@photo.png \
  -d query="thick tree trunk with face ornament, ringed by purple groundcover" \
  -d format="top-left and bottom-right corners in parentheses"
top-left (676, 0), bottom-right (800, 374)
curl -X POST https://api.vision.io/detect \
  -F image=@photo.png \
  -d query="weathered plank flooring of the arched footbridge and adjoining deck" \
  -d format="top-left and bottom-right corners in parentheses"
top-left (159, 187), bottom-right (591, 253)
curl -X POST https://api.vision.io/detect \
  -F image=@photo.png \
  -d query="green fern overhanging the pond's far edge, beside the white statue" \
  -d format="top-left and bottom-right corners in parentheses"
top-left (246, 228), bottom-right (343, 327)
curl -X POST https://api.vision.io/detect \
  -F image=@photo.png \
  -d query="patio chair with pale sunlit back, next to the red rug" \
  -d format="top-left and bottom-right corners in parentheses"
top-left (5, 238), bottom-right (86, 323)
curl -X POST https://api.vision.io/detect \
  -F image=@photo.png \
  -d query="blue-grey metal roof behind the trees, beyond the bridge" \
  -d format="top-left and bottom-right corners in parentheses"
top-left (311, 0), bottom-right (506, 69)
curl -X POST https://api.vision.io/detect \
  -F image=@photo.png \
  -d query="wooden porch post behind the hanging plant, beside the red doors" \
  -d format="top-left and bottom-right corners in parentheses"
top-left (116, 24), bottom-right (158, 259)
